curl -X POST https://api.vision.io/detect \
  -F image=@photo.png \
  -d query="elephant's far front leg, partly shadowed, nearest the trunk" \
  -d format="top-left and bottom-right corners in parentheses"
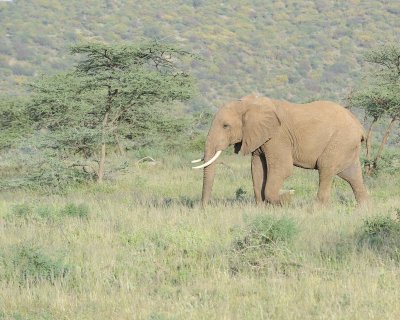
top-left (251, 150), bottom-right (267, 204)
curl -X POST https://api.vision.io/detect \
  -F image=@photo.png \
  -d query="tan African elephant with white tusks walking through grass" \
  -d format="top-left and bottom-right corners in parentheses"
top-left (192, 95), bottom-right (367, 206)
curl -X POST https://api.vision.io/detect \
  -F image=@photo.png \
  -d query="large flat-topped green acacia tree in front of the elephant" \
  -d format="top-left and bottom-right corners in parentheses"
top-left (30, 41), bottom-right (194, 182)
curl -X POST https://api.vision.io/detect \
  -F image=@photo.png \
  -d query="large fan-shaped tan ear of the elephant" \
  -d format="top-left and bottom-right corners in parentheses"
top-left (240, 104), bottom-right (282, 155)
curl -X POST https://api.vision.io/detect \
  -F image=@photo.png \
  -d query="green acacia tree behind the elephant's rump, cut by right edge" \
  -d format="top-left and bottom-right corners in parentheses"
top-left (348, 45), bottom-right (400, 175)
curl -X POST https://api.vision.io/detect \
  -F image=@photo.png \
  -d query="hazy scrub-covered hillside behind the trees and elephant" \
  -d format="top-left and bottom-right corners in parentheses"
top-left (0, 0), bottom-right (400, 109)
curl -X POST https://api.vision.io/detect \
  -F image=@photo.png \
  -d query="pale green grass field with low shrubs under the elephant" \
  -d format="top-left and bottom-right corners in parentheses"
top-left (0, 155), bottom-right (400, 319)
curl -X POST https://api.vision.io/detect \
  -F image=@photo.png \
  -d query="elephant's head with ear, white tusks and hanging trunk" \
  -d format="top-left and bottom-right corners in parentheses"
top-left (192, 96), bottom-right (282, 206)
